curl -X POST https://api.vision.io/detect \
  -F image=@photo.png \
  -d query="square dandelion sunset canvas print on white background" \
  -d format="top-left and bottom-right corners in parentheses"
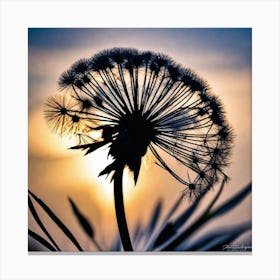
top-left (28, 28), bottom-right (252, 254)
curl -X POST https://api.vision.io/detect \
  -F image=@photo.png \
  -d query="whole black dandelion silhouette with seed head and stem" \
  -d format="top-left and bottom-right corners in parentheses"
top-left (45, 48), bottom-right (232, 251)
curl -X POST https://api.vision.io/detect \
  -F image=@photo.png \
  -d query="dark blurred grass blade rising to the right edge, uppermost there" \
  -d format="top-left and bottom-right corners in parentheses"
top-left (209, 183), bottom-right (252, 218)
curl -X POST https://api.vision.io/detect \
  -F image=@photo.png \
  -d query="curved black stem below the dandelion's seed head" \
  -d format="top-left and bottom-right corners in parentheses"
top-left (114, 167), bottom-right (133, 251)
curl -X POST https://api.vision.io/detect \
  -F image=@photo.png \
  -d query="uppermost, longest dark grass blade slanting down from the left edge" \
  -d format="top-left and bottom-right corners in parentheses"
top-left (28, 190), bottom-right (83, 251)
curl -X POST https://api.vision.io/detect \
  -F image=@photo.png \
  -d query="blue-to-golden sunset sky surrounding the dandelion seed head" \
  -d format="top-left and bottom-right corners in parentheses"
top-left (28, 28), bottom-right (252, 250)
